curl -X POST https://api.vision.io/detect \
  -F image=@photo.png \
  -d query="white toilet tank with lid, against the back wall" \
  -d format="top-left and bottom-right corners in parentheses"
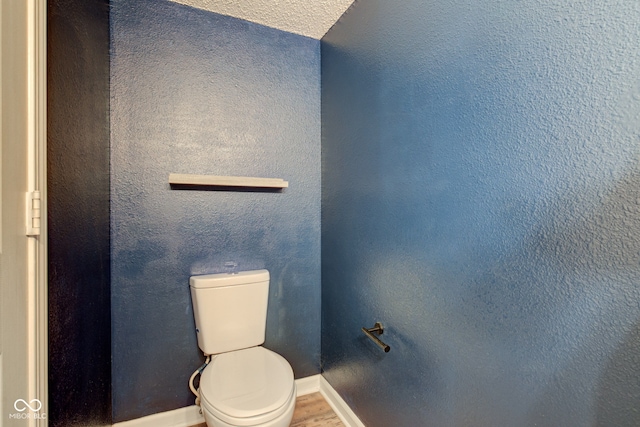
top-left (189, 270), bottom-right (269, 355)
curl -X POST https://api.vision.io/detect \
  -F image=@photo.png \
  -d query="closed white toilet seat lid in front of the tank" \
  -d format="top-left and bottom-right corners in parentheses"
top-left (200, 347), bottom-right (295, 426)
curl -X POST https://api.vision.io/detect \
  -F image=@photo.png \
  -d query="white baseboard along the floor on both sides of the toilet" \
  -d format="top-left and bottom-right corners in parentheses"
top-left (113, 374), bottom-right (365, 427)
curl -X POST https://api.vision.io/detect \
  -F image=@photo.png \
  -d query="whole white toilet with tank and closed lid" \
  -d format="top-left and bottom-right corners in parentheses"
top-left (189, 270), bottom-right (296, 427)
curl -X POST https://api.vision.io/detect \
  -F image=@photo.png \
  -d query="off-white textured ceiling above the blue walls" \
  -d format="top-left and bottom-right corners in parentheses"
top-left (172, 0), bottom-right (354, 39)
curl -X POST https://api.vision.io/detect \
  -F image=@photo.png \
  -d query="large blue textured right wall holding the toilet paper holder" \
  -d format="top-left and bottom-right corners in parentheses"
top-left (322, 0), bottom-right (640, 427)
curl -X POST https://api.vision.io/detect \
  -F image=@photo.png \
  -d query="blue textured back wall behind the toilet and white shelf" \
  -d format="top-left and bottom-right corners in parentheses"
top-left (111, 0), bottom-right (320, 421)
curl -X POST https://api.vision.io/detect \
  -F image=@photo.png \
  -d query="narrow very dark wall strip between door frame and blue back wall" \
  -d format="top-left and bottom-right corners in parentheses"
top-left (47, 0), bottom-right (111, 427)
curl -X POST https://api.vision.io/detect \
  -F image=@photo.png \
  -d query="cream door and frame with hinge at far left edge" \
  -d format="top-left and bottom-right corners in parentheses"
top-left (0, 0), bottom-right (48, 427)
